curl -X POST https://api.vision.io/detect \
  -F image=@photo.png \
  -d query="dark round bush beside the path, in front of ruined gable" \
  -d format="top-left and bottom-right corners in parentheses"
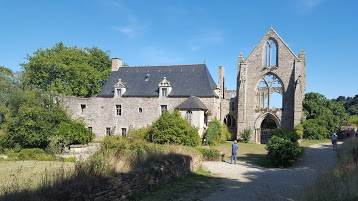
top-left (266, 129), bottom-right (301, 167)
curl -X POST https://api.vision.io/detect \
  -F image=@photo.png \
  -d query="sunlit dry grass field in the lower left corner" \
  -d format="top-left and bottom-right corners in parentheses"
top-left (0, 160), bottom-right (74, 195)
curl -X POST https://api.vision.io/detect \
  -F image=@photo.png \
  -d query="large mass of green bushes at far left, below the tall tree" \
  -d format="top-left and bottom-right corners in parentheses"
top-left (0, 90), bottom-right (94, 149)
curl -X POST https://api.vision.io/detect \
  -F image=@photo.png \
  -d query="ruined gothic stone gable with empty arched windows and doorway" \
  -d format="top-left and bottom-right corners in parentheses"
top-left (235, 27), bottom-right (306, 143)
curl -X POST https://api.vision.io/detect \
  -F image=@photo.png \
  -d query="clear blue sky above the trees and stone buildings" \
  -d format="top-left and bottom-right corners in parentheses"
top-left (0, 0), bottom-right (358, 99)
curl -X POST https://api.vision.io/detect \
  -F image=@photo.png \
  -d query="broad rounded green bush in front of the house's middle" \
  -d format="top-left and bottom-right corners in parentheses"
top-left (148, 110), bottom-right (200, 146)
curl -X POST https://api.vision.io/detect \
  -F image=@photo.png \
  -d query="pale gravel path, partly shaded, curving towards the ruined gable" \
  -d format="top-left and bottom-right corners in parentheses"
top-left (203, 143), bottom-right (337, 201)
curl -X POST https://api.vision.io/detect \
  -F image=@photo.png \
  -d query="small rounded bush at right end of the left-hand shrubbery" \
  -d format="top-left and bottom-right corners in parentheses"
top-left (55, 121), bottom-right (95, 145)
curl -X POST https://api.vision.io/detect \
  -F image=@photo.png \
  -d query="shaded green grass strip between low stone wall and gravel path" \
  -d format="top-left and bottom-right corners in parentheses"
top-left (130, 170), bottom-right (219, 201)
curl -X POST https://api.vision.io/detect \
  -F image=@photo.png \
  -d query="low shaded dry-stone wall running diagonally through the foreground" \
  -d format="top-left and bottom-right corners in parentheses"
top-left (71, 155), bottom-right (202, 201)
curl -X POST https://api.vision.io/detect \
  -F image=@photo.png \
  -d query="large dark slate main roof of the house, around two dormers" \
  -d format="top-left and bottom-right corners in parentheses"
top-left (98, 64), bottom-right (217, 98)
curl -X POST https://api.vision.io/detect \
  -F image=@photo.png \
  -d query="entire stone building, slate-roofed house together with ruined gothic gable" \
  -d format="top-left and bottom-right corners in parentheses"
top-left (65, 28), bottom-right (306, 143)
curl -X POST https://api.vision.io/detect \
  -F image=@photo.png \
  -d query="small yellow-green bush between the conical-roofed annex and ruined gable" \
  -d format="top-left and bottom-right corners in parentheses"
top-left (204, 118), bottom-right (231, 145)
